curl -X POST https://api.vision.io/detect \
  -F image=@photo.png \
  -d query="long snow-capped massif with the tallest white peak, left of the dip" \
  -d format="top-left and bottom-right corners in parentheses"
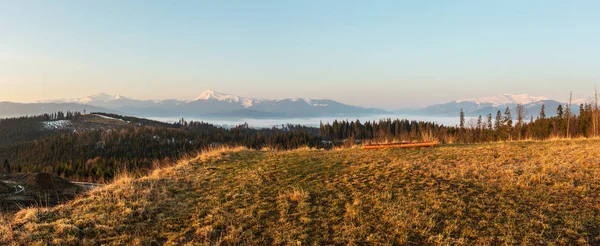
top-left (23, 90), bottom-right (387, 118)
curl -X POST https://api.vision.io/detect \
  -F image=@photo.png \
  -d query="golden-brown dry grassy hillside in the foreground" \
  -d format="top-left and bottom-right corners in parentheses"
top-left (0, 140), bottom-right (600, 245)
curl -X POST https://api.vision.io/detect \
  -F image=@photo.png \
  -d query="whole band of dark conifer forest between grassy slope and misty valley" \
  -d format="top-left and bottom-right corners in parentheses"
top-left (0, 98), bottom-right (599, 182)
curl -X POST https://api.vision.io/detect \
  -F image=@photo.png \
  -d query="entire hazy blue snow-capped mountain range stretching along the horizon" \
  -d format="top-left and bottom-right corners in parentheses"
top-left (0, 90), bottom-right (585, 119)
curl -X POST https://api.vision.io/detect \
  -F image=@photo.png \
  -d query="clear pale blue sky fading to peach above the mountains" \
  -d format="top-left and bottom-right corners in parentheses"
top-left (0, 0), bottom-right (600, 109)
